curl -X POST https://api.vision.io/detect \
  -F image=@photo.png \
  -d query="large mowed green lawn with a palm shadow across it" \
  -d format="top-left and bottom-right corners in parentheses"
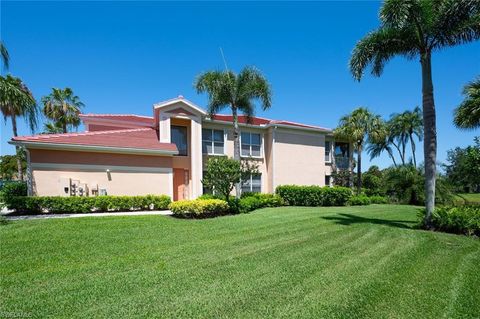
top-left (0, 205), bottom-right (480, 318)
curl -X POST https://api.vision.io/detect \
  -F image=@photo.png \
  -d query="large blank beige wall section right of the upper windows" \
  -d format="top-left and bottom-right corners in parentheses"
top-left (273, 129), bottom-right (326, 187)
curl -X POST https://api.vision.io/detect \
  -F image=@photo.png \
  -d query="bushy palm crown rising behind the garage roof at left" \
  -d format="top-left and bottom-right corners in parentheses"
top-left (42, 88), bottom-right (84, 133)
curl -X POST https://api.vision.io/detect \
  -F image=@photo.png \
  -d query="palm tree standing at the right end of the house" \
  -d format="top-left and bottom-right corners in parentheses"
top-left (334, 107), bottom-right (382, 193)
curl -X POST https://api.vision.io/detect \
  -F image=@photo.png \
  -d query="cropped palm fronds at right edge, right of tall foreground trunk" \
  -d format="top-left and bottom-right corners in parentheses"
top-left (453, 77), bottom-right (480, 129)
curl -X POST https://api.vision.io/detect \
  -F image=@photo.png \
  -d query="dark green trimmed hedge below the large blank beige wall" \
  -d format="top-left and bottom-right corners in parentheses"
top-left (275, 185), bottom-right (352, 206)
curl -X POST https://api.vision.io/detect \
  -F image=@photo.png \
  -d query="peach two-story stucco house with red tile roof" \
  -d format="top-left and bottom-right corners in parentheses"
top-left (10, 96), bottom-right (352, 200)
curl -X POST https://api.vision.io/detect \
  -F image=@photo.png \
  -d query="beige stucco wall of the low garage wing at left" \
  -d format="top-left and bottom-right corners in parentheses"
top-left (29, 149), bottom-right (173, 196)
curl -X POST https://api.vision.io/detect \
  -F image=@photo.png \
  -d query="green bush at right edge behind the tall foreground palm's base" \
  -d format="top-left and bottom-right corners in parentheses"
top-left (420, 206), bottom-right (480, 236)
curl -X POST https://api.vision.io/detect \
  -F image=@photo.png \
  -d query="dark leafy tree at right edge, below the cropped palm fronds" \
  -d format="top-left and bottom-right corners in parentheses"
top-left (444, 136), bottom-right (480, 192)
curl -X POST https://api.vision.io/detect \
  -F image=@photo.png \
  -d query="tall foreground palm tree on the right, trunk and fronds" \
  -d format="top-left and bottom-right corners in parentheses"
top-left (350, 0), bottom-right (480, 227)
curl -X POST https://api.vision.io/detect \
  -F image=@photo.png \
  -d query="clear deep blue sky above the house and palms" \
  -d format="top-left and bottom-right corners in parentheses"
top-left (1, 1), bottom-right (480, 167)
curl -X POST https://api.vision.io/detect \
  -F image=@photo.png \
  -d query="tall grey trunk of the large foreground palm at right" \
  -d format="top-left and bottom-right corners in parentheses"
top-left (420, 51), bottom-right (437, 228)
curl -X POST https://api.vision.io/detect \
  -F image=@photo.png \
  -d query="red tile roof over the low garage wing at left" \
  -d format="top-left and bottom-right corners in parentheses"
top-left (12, 128), bottom-right (177, 152)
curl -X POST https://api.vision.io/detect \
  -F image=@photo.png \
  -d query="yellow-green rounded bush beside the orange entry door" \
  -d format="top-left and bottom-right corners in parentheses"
top-left (169, 199), bottom-right (230, 217)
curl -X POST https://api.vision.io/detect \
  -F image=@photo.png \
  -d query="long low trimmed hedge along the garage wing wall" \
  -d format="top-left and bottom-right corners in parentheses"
top-left (5, 195), bottom-right (171, 214)
